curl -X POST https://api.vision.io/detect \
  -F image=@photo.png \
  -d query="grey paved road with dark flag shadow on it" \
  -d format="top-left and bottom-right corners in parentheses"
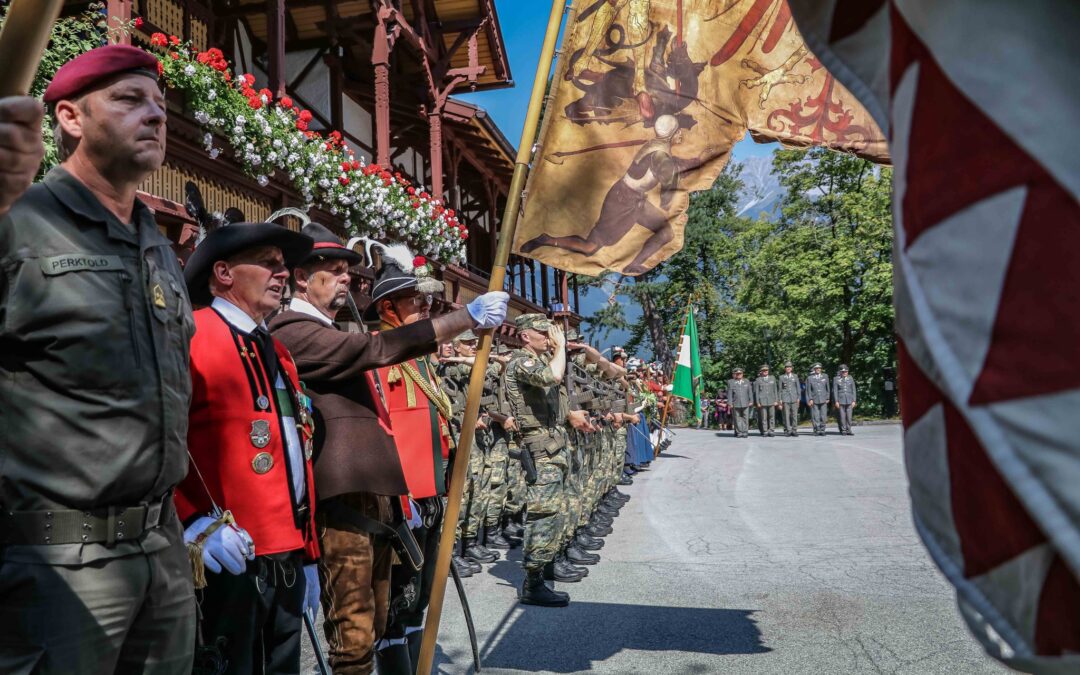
top-left (302, 426), bottom-right (1005, 675)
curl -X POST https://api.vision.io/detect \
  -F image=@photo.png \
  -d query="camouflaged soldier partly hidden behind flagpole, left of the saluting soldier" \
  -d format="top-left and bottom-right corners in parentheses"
top-left (438, 330), bottom-right (499, 564)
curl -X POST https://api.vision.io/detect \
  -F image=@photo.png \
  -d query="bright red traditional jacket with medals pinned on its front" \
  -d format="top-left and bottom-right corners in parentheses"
top-left (176, 308), bottom-right (319, 561)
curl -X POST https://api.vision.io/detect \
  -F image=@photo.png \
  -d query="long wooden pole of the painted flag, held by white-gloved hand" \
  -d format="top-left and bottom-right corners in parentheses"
top-left (416, 0), bottom-right (566, 675)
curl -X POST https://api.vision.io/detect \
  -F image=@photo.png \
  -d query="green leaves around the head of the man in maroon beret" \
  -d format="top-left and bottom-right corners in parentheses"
top-left (0, 2), bottom-right (131, 179)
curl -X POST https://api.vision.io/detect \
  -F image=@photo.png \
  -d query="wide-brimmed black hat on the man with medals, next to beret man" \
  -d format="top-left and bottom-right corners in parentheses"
top-left (184, 222), bottom-right (314, 305)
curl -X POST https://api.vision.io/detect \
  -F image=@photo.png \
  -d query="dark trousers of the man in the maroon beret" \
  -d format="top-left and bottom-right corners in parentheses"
top-left (0, 515), bottom-right (195, 675)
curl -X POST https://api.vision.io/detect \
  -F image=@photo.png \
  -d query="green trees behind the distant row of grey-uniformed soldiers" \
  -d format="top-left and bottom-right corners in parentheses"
top-left (591, 148), bottom-right (895, 414)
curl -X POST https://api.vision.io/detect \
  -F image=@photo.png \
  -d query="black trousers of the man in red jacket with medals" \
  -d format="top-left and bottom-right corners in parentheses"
top-left (200, 551), bottom-right (307, 675)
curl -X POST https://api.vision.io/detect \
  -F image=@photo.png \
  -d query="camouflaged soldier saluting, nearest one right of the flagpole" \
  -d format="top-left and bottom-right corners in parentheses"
top-left (505, 314), bottom-right (596, 607)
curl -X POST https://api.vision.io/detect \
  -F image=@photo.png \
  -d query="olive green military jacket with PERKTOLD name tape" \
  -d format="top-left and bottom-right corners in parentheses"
top-left (0, 167), bottom-right (194, 564)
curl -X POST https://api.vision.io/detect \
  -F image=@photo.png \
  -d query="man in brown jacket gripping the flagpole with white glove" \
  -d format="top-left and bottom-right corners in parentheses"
top-left (270, 224), bottom-right (509, 674)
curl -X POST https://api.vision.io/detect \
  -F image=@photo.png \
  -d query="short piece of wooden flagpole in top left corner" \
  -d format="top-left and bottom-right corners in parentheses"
top-left (0, 0), bottom-right (64, 96)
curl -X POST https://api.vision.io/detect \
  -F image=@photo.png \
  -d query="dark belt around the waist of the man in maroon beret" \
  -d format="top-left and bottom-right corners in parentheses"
top-left (0, 490), bottom-right (173, 546)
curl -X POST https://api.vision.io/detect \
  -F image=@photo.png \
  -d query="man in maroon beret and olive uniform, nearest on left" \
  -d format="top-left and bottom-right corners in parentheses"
top-left (0, 45), bottom-right (195, 674)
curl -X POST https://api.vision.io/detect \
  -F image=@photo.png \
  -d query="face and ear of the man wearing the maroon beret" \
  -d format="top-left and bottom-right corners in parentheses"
top-left (57, 75), bottom-right (166, 181)
